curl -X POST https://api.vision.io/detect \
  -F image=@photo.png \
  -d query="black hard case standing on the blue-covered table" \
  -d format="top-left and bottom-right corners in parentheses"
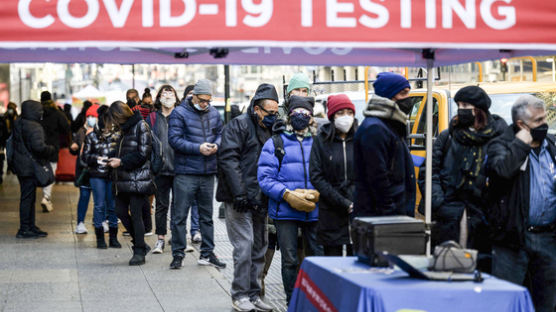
top-left (351, 216), bottom-right (427, 266)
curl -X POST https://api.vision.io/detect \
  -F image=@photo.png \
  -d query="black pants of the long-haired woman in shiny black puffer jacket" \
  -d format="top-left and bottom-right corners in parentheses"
top-left (116, 193), bottom-right (149, 248)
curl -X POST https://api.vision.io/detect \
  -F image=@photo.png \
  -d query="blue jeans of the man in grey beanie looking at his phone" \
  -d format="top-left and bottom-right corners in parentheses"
top-left (170, 175), bottom-right (214, 258)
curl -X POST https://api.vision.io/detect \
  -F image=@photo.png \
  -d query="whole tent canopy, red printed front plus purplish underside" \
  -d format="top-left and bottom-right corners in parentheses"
top-left (4, 0), bottom-right (556, 66)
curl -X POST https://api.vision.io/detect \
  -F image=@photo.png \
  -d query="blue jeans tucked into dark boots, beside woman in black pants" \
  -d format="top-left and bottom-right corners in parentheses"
top-left (90, 178), bottom-right (118, 228)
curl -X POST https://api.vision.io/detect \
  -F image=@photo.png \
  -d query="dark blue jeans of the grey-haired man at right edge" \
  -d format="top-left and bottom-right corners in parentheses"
top-left (492, 231), bottom-right (556, 312)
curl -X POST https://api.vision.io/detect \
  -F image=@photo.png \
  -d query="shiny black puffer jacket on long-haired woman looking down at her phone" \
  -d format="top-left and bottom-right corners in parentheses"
top-left (113, 112), bottom-right (154, 195)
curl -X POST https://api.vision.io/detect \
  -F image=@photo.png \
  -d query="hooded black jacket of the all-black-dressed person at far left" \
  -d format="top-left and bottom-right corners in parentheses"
top-left (13, 101), bottom-right (57, 177)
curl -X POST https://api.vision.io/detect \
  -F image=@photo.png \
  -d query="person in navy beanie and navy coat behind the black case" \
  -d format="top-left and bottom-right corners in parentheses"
top-left (353, 72), bottom-right (416, 217)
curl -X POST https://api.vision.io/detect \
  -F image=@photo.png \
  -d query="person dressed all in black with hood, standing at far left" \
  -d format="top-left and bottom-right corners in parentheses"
top-left (12, 100), bottom-right (56, 238)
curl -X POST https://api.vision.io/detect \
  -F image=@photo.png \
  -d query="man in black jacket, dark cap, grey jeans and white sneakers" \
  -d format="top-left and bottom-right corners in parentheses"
top-left (216, 83), bottom-right (278, 311)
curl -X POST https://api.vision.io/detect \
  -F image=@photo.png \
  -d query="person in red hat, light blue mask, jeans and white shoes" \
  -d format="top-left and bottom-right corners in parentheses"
top-left (70, 105), bottom-right (96, 234)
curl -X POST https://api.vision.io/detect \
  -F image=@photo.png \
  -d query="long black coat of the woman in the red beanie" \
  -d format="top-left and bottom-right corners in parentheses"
top-left (309, 121), bottom-right (357, 246)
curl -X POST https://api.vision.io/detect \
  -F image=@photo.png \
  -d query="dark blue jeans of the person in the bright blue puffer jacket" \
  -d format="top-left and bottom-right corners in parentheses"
top-left (274, 220), bottom-right (323, 303)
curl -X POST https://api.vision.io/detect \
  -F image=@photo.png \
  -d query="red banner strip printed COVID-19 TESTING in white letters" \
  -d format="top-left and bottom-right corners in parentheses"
top-left (0, 0), bottom-right (556, 50)
